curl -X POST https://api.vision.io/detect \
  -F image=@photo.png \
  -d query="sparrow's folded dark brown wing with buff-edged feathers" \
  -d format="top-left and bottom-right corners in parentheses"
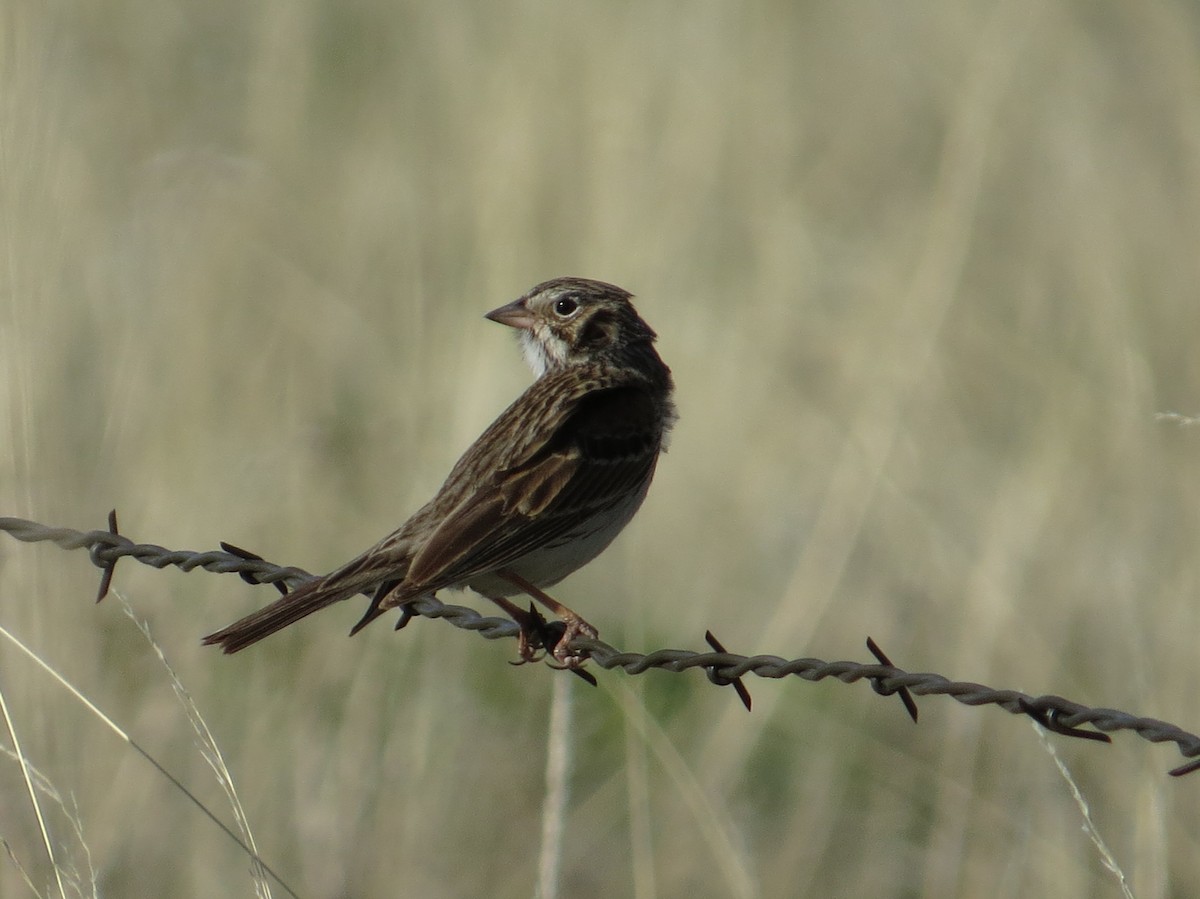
top-left (403, 385), bottom-right (661, 595)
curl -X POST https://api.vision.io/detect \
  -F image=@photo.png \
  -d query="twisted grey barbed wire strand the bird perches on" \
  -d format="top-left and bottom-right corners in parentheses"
top-left (0, 513), bottom-right (1200, 777)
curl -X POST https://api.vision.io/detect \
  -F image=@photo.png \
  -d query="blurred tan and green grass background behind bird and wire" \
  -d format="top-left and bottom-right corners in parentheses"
top-left (0, 0), bottom-right (1200, 898)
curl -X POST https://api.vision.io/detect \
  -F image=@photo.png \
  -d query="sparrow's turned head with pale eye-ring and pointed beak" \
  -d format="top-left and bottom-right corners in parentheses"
top-left (487, 277), bottom-right (656, 377)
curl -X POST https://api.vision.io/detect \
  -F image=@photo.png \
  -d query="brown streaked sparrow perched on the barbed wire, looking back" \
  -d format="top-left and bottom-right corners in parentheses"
top-left (204, 277), bottom-right (676, 666)
